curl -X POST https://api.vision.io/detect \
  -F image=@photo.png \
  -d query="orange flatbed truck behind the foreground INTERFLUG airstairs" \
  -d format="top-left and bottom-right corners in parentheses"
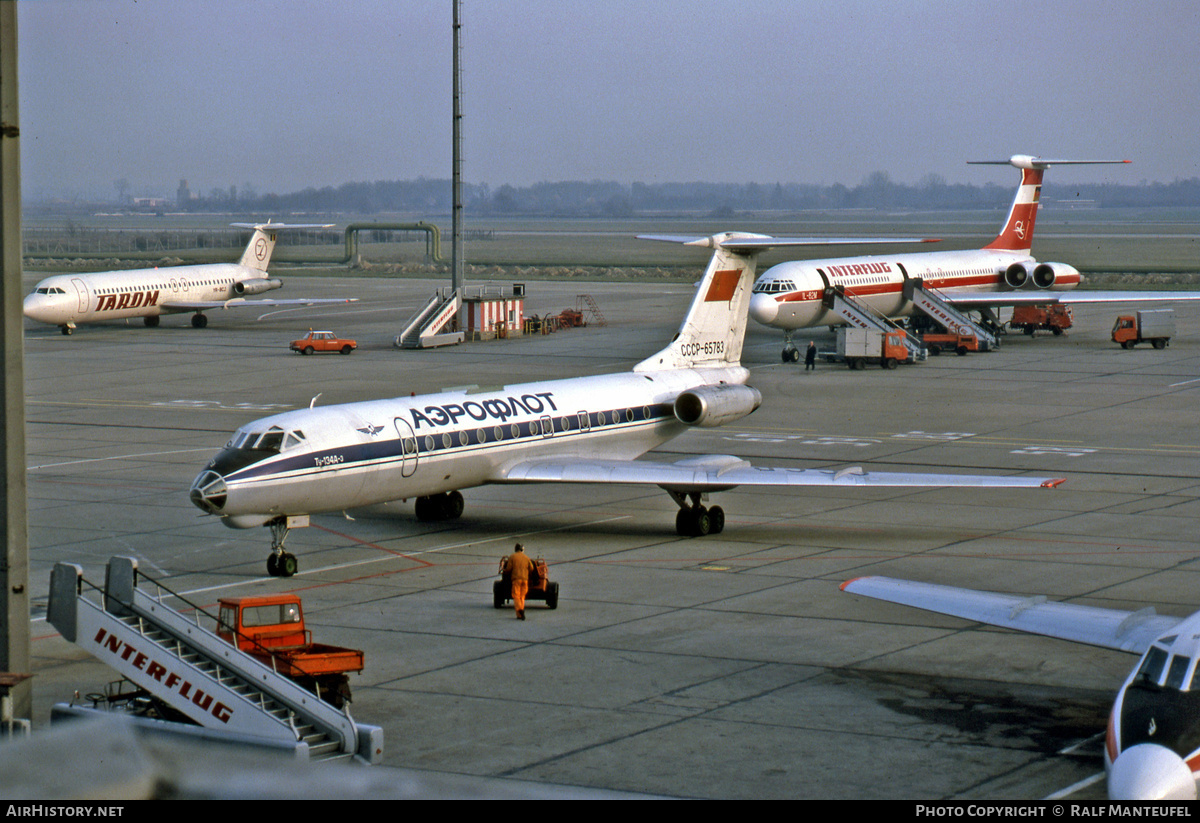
top-left (217, 594), bottom-right (362, 708)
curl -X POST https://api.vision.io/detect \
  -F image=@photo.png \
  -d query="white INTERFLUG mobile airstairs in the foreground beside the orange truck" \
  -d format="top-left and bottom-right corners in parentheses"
top-left (47, 557), bottom-right (383, 763)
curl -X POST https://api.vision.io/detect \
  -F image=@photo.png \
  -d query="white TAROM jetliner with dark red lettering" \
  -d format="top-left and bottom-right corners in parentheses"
top-left (24, 223), bottom-right (354, 335)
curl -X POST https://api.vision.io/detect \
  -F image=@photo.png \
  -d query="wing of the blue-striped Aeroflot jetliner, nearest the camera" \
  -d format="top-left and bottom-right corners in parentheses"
top-left (493, 455), bottom-right (1062, 492)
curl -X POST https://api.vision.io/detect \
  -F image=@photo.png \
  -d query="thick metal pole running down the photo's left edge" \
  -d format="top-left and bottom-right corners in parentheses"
top-left (0, 0), bottom-right (34, 717)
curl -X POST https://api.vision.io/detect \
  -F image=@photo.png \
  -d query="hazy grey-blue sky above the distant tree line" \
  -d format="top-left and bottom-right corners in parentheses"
top-left (18, 0), bottom-right (1200, 197)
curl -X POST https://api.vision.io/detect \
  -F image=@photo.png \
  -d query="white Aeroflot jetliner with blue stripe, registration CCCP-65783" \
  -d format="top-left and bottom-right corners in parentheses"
top-left (191, 233), bottom-right (1061, 576)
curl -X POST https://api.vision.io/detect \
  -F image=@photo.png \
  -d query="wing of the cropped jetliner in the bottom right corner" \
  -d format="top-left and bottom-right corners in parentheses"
top-left (841, 577), bottom-right (1183, 654)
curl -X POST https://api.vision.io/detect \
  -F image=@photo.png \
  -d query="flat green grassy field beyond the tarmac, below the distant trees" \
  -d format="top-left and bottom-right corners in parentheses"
top-left (25, 205), bottom-right (1200, 278)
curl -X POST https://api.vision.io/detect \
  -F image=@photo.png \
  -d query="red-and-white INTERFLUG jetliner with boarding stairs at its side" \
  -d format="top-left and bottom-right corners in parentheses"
top-left (750, 155), bottom-right (1200, 362)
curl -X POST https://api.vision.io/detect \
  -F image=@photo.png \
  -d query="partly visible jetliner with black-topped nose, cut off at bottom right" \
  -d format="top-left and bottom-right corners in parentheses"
top-left (841, 577), bottom-right (1200, 800)
